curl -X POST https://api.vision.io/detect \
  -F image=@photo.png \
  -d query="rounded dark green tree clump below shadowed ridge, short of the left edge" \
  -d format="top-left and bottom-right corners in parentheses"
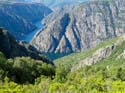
top-left (9, 57), bottom-right (55, 83)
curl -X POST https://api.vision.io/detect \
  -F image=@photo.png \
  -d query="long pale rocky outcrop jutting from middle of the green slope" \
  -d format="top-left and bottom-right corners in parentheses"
top-left (72, 45), bottom-right (115, 70)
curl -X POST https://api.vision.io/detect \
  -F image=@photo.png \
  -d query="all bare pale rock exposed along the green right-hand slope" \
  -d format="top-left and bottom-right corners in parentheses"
top-left (71, 36), bottom-right (125, 71)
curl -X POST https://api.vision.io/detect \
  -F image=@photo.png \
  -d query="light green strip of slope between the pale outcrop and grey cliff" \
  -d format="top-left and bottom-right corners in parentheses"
top-left (54, 37), bottom-right (121, 66)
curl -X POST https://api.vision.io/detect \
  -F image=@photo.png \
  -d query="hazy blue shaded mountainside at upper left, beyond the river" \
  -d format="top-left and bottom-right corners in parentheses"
top-left (0, 3), bottom-right (52, 40)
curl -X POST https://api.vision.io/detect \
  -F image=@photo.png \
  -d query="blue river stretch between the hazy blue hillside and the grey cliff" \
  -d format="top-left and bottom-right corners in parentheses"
top-left (24, 21), bottom-right (44, 43)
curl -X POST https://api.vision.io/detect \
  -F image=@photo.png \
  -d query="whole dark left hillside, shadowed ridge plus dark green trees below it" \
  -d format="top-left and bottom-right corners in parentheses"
top-left (0, 28), bottom-right (55, 83)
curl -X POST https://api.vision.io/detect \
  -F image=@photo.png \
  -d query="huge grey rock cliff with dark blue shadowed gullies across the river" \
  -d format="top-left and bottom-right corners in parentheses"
top-left (32, 0), bottom-right (125, 53)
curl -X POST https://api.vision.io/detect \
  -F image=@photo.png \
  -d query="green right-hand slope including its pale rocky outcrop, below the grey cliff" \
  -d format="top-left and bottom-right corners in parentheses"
top-left (54, 35), bottom-right (125, 71)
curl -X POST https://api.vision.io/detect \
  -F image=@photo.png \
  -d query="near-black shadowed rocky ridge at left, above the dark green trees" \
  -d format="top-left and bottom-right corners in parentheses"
top-left (0, 28), bottom-right (52, 63)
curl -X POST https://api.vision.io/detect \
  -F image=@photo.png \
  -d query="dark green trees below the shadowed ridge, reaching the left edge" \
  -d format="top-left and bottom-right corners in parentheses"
top-left (0, 53), bottom-right (55, 83)
